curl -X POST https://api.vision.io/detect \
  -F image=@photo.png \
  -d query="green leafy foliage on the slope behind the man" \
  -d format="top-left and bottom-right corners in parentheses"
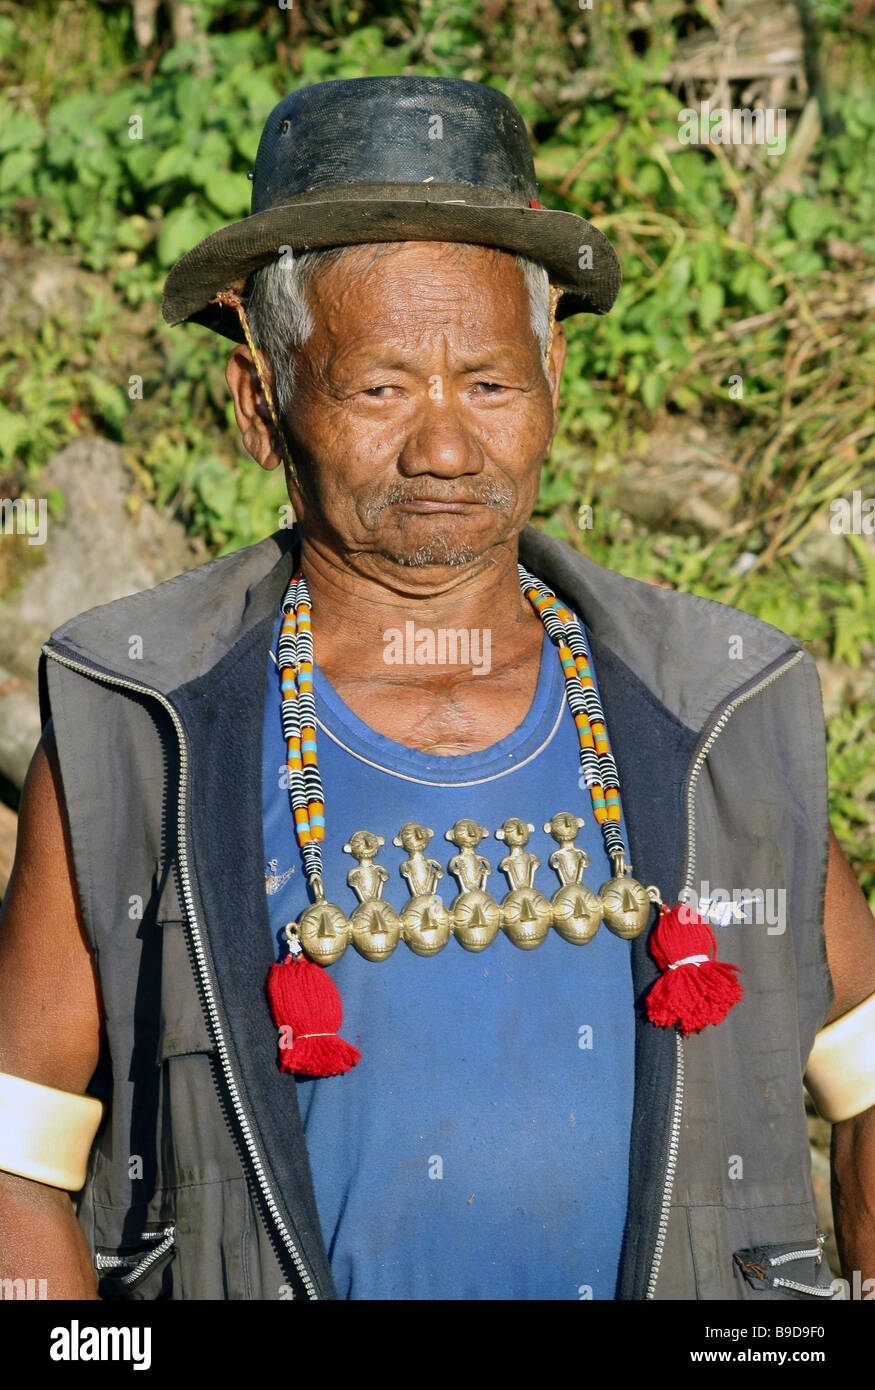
top-left (0, 0), bottom-right (875, 902)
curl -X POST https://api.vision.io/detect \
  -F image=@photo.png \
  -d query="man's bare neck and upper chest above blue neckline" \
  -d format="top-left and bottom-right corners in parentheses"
top-left (293, 539), bottom-right (544, 756)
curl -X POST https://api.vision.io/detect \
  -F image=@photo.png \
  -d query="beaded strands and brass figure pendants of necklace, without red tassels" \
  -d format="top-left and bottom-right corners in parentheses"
top-left (277, 564), bottom-right (661, 965)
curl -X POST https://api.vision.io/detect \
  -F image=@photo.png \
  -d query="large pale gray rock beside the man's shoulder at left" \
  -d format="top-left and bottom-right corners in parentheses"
top-left (0, 438), bottom-right (209, 787)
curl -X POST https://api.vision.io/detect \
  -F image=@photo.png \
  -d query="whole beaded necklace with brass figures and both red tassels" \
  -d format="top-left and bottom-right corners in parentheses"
top-left (267, 564), bottom-right (741, 1076)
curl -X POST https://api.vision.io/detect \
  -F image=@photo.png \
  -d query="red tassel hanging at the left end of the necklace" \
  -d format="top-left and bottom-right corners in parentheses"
top-left (267, 955), bottom-right (362, 1076)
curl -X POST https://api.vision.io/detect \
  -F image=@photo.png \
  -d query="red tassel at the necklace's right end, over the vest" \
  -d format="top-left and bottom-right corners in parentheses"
top-left (647, 904), bottom-right (744, 1037)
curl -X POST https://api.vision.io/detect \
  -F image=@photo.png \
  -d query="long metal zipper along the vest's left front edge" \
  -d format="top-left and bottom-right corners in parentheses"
top-left (42, 645), bottom-right (319, 1300)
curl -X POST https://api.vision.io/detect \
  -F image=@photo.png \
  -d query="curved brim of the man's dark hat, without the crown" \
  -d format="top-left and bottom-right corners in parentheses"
top-left (161, 185), bottom-right (622, 342)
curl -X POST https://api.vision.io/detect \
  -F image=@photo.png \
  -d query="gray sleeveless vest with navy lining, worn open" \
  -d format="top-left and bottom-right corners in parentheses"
top-left (40, 527), bottom-right (832, 1300)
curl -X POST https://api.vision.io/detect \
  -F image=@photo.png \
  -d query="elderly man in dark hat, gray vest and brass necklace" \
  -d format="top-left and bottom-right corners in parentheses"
top-left (0, 78), bottom-right (875, 1300)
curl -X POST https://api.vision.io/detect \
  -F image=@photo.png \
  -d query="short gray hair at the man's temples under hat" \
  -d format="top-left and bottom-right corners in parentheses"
top-left (246, 242), bottom-right (549, 414)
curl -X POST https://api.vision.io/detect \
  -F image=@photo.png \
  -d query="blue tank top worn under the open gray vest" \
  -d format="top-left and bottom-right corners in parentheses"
top-left (262, 600), bottom-right (634, 1300)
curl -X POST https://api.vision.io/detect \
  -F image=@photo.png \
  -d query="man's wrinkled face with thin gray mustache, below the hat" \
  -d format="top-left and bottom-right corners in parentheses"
top-left (228, 242), bottom-right (563, 566)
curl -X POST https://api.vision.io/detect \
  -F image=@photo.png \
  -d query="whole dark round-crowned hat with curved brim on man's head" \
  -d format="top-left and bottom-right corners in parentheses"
top-left (163, 76), bottom-right (622, 342)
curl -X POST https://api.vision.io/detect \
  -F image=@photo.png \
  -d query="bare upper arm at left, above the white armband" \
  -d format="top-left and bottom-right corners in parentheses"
top-left (0, 720), bottom-right (100, 1093)
